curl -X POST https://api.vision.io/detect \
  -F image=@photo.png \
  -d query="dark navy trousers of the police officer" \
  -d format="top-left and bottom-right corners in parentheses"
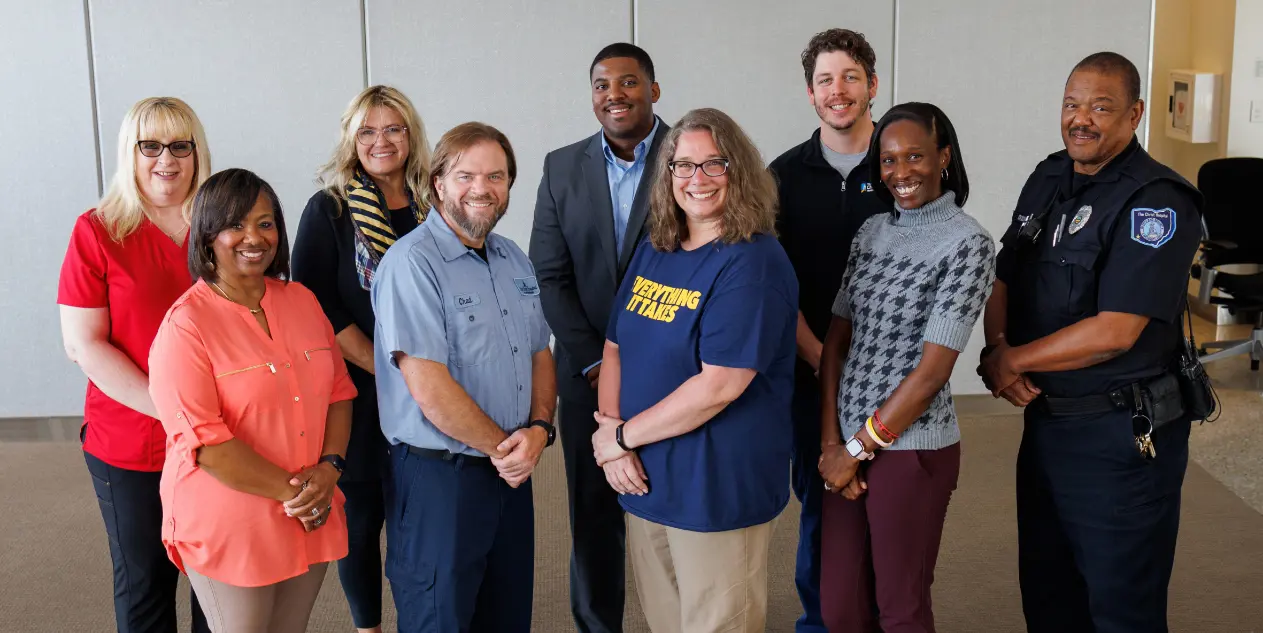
top-left (1017, 402), bottom-right (1190, 633)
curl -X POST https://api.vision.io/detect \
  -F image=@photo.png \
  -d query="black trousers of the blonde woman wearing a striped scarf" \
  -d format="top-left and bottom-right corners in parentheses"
top-left (337, 479), bottom-right (386, 629)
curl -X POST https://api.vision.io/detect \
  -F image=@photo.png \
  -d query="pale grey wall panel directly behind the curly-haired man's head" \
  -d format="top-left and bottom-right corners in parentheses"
top-left (637, 0), bottom-right (894, 169)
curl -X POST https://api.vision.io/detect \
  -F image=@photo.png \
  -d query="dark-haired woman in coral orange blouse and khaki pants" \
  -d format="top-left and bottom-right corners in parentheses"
top-left (149, 169), bottom-right (356, 633)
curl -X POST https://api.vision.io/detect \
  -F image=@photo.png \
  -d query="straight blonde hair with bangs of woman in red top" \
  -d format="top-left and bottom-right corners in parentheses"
top-left (96, 97), bottom-right (211, 241)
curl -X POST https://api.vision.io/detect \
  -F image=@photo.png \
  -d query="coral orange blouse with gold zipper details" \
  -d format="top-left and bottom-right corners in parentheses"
top-left (149, 279), bottom-right (356, 586)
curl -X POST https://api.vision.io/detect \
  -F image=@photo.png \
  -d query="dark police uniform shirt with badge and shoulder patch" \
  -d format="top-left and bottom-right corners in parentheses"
top-left (997, 138), bottom-right (1201, 397)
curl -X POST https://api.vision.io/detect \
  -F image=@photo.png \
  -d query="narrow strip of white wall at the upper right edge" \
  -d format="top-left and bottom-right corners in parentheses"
top-left (1228, 0), bottom-right (1263, 157)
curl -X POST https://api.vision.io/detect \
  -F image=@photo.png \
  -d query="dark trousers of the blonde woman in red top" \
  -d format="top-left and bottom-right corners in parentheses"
top-left (83, 451), bottom-right (211, 633)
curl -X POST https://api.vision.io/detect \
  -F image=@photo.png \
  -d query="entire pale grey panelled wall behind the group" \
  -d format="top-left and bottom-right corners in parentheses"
top-left (0, 0), bottom-right (1156, 417)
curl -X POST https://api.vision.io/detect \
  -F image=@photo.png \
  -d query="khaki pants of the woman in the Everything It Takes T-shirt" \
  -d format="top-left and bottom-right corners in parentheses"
top-left (628, 514), bottom-right (774, 633)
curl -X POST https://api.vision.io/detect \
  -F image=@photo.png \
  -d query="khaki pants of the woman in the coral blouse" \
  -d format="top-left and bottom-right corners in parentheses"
top-left (187, 562), bottom-right (328, 633)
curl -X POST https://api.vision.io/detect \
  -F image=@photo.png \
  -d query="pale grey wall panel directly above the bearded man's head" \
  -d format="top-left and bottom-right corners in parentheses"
top-left (366, 0), bottom-right (632, 250)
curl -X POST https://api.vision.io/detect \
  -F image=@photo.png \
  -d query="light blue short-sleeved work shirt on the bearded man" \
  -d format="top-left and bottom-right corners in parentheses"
top-left (373, 208), bottom-right (552, 456)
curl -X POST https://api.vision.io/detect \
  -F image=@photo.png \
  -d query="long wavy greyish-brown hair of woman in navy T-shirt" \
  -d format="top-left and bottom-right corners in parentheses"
top-left (649, 107), bottom-right (778, 253)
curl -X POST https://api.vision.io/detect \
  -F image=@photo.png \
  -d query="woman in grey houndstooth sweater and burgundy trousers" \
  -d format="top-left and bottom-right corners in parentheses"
top-left (820, 104), bottom-right (995, 632)
